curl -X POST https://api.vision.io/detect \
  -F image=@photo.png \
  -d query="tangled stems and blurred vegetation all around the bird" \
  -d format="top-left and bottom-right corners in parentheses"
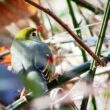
top-left (0, 0), bottom-right (110, 110)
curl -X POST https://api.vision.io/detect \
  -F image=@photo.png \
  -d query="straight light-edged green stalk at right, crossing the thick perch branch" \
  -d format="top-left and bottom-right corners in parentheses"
top-left (89, 0), bottom-right (110, 83)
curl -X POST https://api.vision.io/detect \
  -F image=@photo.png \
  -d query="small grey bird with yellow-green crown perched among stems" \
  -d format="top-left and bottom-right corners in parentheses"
top-left (11, 27), bottom-right (55, 95)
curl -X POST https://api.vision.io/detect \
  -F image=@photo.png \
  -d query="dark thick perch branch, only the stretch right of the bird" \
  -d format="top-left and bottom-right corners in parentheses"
top-left (48, 54), bottom-right (110, 90)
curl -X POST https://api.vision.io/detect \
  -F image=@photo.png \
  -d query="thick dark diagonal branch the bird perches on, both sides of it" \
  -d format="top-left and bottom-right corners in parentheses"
top-left (6, 55), bottom-right (110, 110)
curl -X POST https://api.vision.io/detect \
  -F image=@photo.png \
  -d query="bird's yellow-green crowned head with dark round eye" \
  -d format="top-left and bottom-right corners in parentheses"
top-left (15, 27), bottom-right (42, 41)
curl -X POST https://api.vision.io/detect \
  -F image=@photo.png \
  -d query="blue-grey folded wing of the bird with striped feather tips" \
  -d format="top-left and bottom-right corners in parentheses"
top-left (34, 42), bottom-right (55, 81)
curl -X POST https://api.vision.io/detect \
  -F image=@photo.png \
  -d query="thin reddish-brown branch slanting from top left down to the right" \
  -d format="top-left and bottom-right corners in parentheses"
top-left (25, 0), bottom-right (105, 66)
